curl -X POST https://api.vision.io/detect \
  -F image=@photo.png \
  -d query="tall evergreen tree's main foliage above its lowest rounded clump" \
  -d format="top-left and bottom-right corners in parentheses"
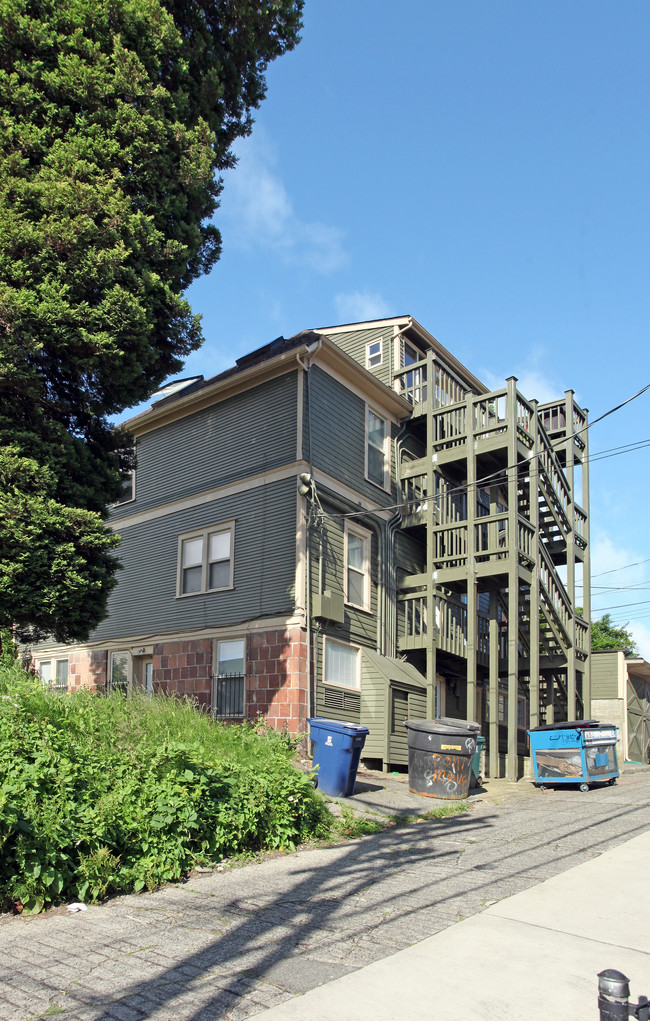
top-left (0, 0), bottom-right (303, 637)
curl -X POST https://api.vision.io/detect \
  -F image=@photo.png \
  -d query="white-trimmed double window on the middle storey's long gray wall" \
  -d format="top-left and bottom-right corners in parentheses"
top-left (177, 521), bottom-right (235, 599)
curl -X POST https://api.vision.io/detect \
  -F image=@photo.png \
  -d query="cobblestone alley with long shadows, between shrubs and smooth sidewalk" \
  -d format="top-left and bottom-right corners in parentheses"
top-left (5, 769), bottom-right (650, 1021)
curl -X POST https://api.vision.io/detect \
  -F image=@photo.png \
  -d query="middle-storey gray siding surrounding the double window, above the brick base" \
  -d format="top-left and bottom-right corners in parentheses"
top-left (91, 478), bottom-right (296, 641)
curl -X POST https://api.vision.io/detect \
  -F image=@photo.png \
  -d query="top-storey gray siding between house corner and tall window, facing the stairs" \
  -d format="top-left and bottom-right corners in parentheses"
top-left (303, 366), bottom-right (396, 505)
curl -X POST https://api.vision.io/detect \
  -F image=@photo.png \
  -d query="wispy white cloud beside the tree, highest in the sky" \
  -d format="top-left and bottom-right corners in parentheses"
top-left (219, 128), bottom-right (347, 274)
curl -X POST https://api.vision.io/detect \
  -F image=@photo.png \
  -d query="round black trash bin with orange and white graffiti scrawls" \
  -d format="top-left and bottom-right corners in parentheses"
top-left (405, 719), bottom-right (481, 800)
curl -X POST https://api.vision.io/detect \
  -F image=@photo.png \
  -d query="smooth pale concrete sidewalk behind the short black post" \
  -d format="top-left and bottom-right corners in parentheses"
top-left (259, 832), bottom-right (650, 1021)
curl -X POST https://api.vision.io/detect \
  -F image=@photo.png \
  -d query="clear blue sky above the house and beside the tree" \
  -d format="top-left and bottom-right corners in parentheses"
top-left (117, 0), bottom-right (650, 659)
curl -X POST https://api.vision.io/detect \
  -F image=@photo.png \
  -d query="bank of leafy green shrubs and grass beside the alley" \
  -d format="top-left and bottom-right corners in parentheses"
top-left (0, 661), bottom-right (330, 913)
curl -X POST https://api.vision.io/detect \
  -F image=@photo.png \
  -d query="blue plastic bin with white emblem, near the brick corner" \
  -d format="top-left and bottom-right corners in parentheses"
top-left (307, 717), bottom-right (368, 797)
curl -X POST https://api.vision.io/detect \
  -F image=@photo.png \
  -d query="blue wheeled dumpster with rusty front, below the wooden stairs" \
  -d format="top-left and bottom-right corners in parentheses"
top-left (529, 720), bottom-right (618, 790)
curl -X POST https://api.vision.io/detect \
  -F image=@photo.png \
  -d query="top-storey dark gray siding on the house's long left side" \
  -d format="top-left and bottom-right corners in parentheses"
top-left (111, 370), bottom-right (298, 520)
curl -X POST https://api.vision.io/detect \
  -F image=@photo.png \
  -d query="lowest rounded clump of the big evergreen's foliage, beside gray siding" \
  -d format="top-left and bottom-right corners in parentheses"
top-left (0, 447), bottom-right (118, 641)
